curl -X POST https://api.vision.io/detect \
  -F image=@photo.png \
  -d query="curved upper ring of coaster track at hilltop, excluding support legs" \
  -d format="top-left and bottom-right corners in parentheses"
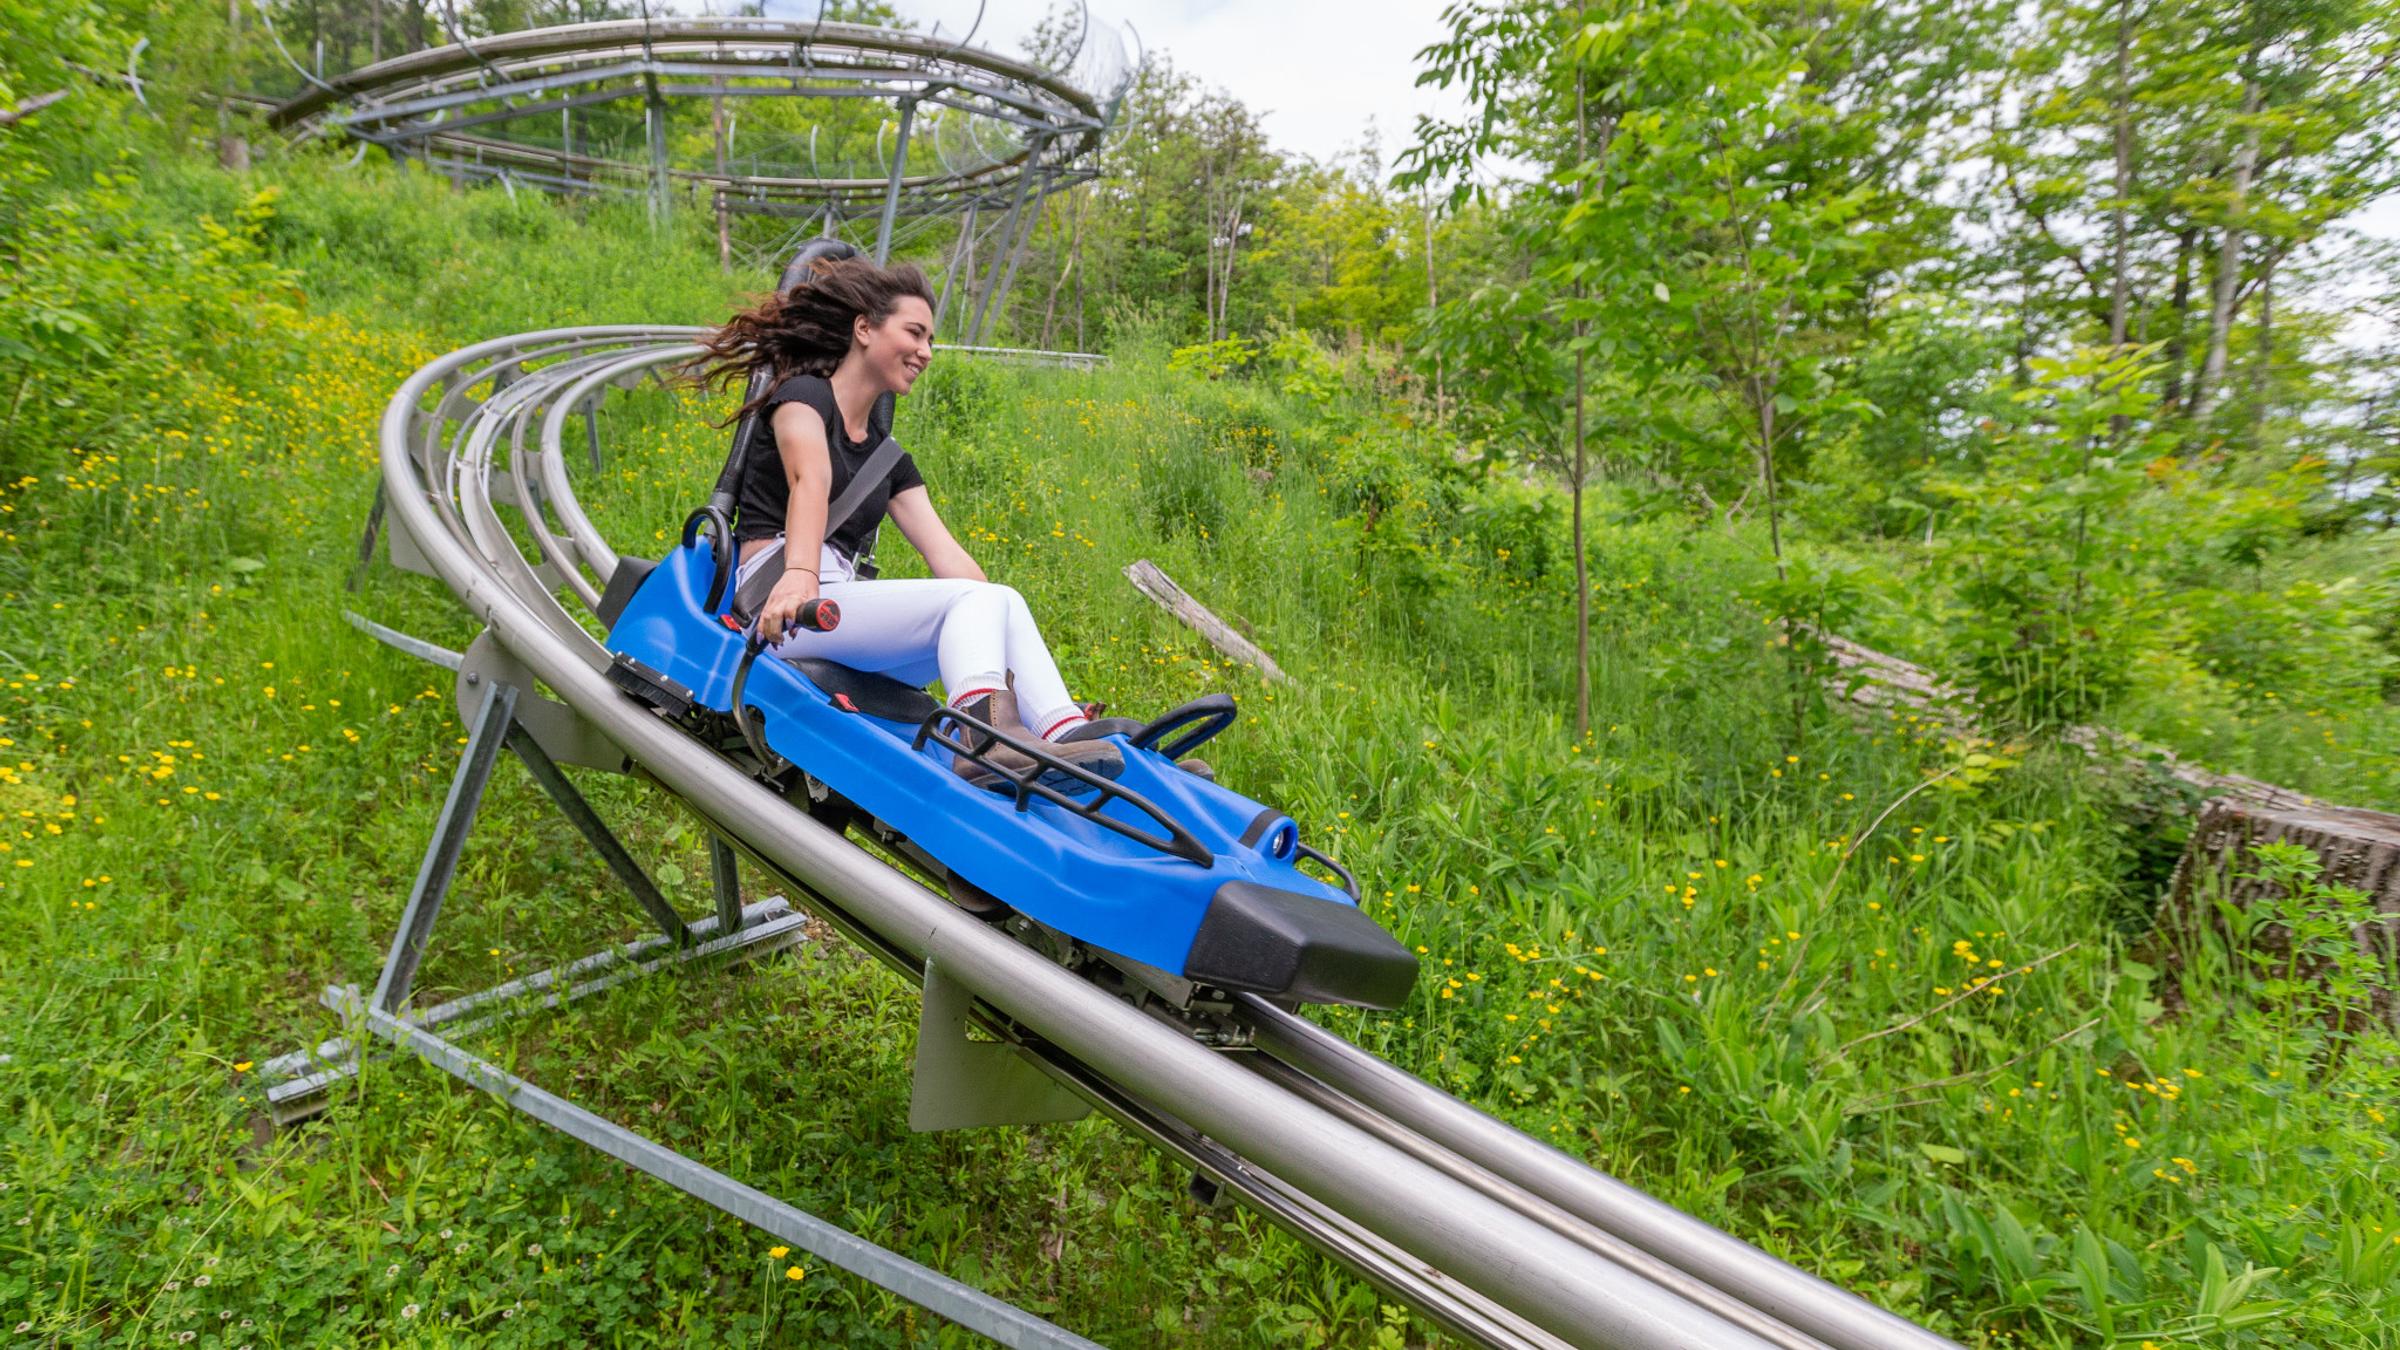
top-left (269, 14), bottom-right (1130, 214)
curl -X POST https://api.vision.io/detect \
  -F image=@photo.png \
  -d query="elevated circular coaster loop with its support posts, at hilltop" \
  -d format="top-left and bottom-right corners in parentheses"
top-left (262, 10), bottom-right (1138, 344)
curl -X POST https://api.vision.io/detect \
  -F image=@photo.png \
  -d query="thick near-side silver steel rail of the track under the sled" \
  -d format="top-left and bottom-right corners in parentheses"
top-left (382, 329), bottom-right (1764, 1348)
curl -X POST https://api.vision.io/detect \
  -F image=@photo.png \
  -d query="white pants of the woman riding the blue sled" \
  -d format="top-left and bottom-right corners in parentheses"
top-left (734, 535), bottom-right (1082, 735)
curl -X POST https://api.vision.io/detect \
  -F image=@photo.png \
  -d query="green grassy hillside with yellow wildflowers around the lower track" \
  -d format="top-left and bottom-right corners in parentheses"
top-left (0, 141), bottom-right (2400, 1345)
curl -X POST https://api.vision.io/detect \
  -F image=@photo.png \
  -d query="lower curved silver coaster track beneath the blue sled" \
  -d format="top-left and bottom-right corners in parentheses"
top-left (364, 327), bottom-right (1951, 1350)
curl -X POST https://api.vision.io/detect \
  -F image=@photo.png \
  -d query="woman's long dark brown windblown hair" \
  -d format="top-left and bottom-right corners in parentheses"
top-left (684, 257), bottom-right (934, 423)
